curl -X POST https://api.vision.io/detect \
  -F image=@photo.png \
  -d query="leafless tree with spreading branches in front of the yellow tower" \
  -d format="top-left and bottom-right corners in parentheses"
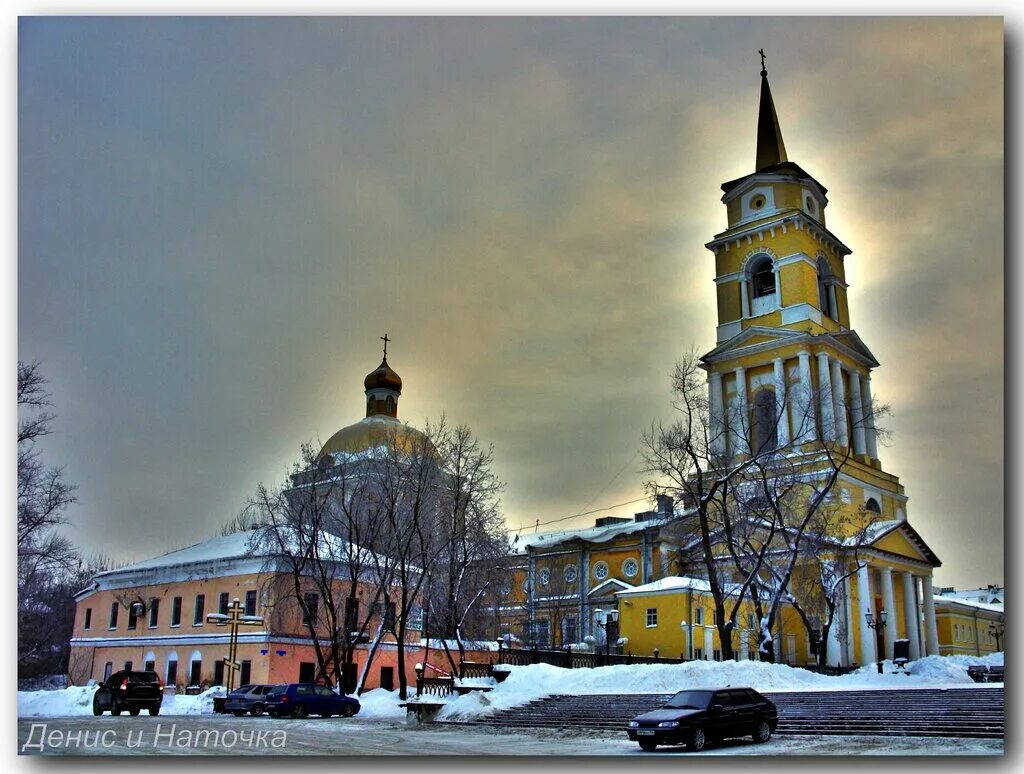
top-left (643, 353), bottom-right (883, 660)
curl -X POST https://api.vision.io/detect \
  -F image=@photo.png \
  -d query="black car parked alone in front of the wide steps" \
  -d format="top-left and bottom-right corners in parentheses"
top-left (628, 687), bottom-right (778, 751)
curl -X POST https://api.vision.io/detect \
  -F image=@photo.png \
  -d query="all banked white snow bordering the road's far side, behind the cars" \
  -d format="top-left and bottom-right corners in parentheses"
top-left (17, 653), bottom-right (1002, 720)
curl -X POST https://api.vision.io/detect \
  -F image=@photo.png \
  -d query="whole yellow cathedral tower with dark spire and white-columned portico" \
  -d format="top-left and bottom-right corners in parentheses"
top-left (620, 60), bottom-right (940, 665)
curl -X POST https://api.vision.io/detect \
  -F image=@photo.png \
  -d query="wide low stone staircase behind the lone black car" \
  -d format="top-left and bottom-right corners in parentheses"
top-left (454, 687), bottom-right (1004, 739)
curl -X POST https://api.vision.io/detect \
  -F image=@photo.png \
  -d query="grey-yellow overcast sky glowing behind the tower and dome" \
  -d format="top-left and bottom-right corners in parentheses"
top-left (18, 18), bottom-right (1004, 586)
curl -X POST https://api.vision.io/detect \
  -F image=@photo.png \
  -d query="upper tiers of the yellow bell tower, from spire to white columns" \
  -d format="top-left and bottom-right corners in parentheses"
top-left (703, 51), bottom-right (881, 470)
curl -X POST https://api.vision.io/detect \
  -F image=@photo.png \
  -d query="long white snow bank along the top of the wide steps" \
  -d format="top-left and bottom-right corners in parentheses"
top-left (438, 653), bottom-right (1002, 720)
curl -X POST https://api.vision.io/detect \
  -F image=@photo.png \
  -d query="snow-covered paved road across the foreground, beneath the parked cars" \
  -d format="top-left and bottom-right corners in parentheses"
top-left (17, 716), bottom-right (1002, 757)
